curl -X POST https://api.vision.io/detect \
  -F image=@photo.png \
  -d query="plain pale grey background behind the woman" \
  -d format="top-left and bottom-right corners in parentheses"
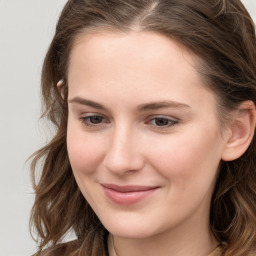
top-left (0, 0), bottom-right (256, 256)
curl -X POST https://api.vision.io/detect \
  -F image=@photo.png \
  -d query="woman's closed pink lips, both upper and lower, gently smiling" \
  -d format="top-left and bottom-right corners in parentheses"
top-left (102, 184), bottom-right (159, 205)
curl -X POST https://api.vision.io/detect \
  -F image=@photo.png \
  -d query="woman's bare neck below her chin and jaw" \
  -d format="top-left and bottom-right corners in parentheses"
top-left (111, 213), bottom-right (218, 256)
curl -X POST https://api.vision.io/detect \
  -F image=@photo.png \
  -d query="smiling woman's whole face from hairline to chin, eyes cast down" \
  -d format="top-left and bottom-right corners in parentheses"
top-left (67, 32), bottom-right (228, 238)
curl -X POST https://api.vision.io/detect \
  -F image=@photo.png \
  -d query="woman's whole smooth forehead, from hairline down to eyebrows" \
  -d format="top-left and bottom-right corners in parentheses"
top-left (68, 31), bottom-right (216, 111)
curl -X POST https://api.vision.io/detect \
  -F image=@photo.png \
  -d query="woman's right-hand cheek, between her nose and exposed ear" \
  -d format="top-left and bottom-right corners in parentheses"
top-left (149, 126), bottom-right (221, 191)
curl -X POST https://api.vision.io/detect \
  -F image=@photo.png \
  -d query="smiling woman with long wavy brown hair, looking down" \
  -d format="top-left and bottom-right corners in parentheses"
top-left (31, 0), bottom-right (256, 256)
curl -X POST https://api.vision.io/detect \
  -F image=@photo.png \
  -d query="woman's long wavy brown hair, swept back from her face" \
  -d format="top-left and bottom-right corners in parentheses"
top-left (31, 0), bottom-right (256, 256)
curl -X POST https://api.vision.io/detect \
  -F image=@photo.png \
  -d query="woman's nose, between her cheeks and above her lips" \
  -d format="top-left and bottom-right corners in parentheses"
top-left (103, 124), bottom-right (144, 176)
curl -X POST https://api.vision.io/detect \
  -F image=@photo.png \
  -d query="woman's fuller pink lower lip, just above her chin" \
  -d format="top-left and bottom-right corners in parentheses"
top-left (103, 187), bottom-right (158, 205)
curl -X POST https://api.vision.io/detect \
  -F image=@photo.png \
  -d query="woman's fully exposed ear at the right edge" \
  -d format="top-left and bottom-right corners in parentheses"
top-left (222, 101), bottom-right (256, 161)
